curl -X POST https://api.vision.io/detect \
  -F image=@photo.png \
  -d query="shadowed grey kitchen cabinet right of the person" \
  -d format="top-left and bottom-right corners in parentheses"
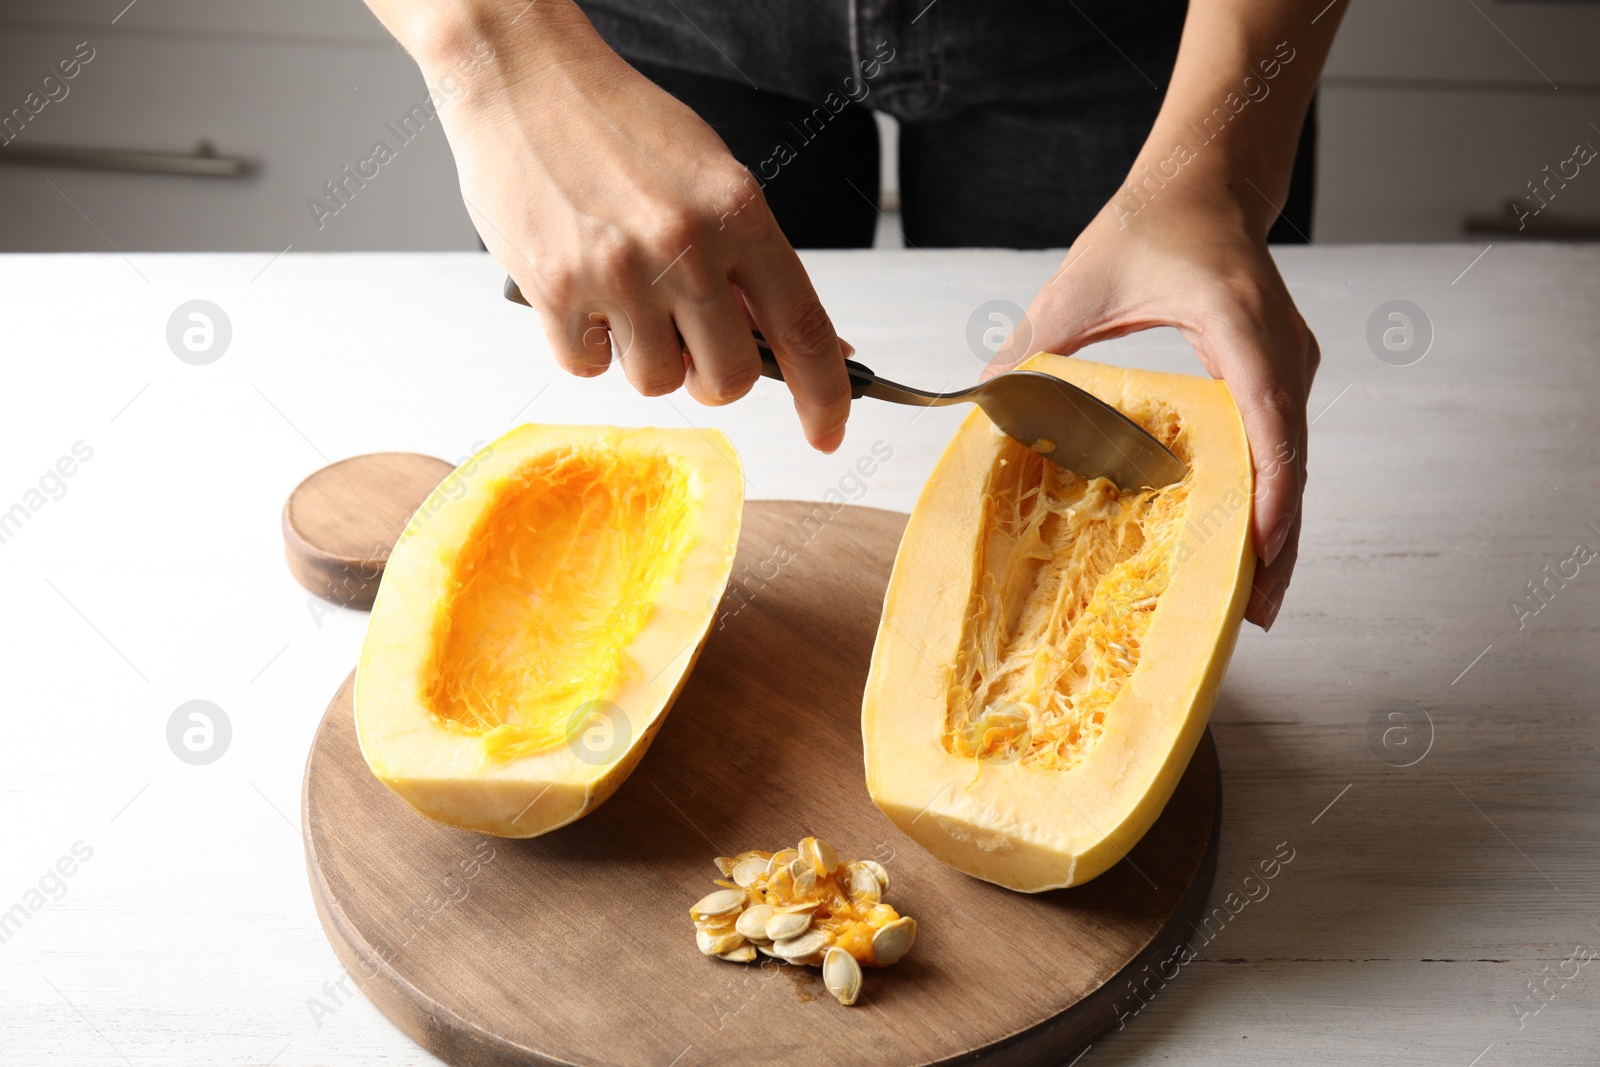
top-left (1312, 0), bottom-right (1600, 243)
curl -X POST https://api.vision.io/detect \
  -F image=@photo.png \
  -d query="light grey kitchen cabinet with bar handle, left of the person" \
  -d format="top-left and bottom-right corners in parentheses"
top-left (0, 0), bottom-right (478, 253)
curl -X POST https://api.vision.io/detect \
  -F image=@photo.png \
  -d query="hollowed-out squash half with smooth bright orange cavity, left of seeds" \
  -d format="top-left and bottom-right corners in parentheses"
top-left (355, 426), bottom-right (744, 837)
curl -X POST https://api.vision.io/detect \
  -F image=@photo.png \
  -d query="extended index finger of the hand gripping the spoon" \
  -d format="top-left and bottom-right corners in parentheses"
top-left (734, 239), bottom-right (850, 453)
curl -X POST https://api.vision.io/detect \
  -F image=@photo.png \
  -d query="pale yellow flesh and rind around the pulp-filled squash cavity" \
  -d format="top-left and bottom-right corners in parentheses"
top-left (861, 354), bottom-right (1254, 893)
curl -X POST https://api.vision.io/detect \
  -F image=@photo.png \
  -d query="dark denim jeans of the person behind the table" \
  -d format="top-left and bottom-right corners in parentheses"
top-left (579, 0), bottom-right (1314, 248)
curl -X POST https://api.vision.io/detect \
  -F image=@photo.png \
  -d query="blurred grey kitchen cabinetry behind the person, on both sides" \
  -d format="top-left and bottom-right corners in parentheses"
top-left (0, 0), bottom-right (1600, 253)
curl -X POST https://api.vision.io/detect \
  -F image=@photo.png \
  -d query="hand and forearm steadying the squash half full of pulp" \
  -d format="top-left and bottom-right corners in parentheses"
top-left (989, 0), bottom-right (1344, 629)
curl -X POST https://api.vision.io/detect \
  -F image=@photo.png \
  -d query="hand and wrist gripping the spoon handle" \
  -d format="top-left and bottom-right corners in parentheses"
top-left (368, 0), bottom-right (850, 451)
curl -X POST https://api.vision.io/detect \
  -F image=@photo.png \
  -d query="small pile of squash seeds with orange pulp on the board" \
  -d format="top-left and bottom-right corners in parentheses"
top-left (690, 837), bottom-right (917, 1006)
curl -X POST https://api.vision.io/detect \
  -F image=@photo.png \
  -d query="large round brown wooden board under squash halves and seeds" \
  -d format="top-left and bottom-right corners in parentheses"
top-left (302, 502), bottom-right (1221, 1067)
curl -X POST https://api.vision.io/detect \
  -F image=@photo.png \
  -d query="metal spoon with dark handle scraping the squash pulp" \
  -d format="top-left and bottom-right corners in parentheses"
top-left (506, 278), bottom-right (1189, 490)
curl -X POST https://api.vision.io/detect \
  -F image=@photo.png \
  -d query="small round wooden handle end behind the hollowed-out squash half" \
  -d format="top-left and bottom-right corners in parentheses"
top-left (283, 453), bottom-right (454, 608)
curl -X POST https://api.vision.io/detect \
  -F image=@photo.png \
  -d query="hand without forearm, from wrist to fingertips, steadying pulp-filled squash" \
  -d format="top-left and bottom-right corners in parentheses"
top-left (987, 187), bottom-right (1320, 629)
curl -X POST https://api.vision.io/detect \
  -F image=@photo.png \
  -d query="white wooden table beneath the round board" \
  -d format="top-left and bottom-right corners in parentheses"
top-left (0, 245), bottom-right (1600, 1067)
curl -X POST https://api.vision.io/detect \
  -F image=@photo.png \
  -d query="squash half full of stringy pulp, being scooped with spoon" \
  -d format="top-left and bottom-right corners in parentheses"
top-left (861, 354), bottom-right (1254, 893)
